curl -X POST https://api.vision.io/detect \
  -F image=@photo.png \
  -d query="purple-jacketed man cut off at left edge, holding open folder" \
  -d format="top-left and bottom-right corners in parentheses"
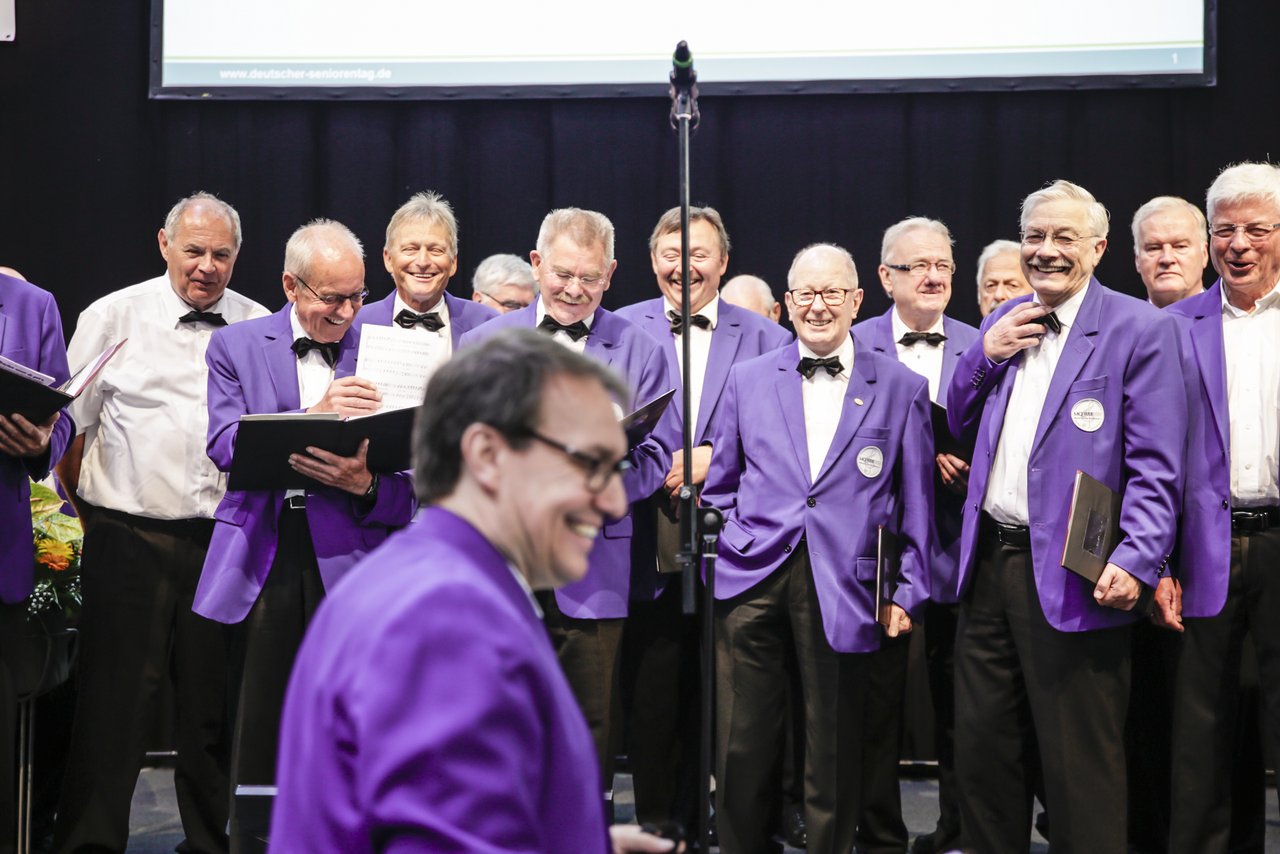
top-left (0, 274), bottom-right (74, 849)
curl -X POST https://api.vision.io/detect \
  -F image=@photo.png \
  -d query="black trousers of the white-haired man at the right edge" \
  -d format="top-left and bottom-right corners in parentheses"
top-left (1170, 529), bottom-right (1280, 854)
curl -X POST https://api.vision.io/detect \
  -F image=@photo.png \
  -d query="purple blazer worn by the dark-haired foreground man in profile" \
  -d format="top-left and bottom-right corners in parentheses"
top-left (270, 507), bottom-right (612, 854)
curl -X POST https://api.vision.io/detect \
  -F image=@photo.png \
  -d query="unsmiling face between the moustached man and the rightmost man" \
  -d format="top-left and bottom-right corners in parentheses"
top-left (1134, 207), bottom-right (1208, 309)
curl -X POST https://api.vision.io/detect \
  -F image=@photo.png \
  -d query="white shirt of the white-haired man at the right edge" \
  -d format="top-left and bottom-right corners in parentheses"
top-left (1222, 286), bottom-right (1280, 507)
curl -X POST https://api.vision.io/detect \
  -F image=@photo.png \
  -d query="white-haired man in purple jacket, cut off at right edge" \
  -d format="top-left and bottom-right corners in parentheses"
top-left (1169, 163), bottom-right (1280, 853)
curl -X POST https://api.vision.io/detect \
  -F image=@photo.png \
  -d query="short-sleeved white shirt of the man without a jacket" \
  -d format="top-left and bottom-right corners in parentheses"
top-left (67, 274), bottom-right (269, 519)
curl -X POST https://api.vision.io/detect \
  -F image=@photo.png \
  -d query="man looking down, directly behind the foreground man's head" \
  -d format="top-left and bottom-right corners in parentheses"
top-left (462, 207), bottom-right (675, 803)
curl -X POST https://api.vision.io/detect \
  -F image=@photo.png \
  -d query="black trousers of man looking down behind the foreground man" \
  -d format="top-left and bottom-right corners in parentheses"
top-left (538, 592), bottom-right (625, 800)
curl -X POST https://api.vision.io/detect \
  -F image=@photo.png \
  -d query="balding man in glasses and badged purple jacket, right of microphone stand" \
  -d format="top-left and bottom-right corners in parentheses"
top-left (703, 245), bottom-right (934, 854)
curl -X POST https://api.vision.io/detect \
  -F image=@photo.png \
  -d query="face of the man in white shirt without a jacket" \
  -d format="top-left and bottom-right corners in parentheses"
top-left (157, 201), bottom-right (239, 311)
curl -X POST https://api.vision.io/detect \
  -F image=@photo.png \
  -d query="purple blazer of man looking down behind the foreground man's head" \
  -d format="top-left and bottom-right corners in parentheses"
top-left (462, 301), bottom-right (675, 620)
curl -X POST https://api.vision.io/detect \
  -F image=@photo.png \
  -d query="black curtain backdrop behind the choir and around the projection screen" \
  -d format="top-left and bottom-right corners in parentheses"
top-left (0, 0), bottom-right (1280, 335)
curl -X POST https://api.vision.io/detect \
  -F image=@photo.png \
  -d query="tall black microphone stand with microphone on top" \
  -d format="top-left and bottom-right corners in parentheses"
top-left (671, 41), bottom-right (721, 853)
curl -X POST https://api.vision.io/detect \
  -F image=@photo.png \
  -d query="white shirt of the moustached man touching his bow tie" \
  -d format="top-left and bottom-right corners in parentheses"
top-left (982, 284), bottom-right (1089, 525)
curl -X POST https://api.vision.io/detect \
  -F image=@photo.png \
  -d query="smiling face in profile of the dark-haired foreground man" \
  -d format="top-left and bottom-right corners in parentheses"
top-left (495, 375), bottom-right (627, 589)
